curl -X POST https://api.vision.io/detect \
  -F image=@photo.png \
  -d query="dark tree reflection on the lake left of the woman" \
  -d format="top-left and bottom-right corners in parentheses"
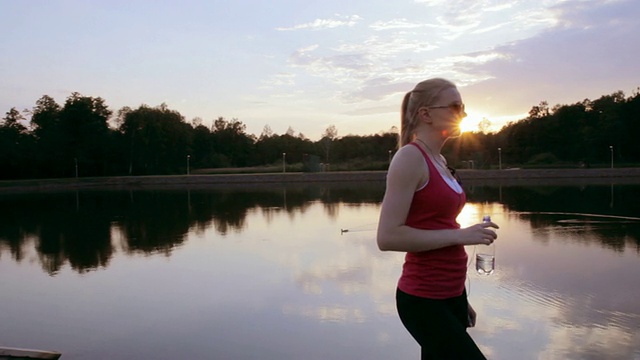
top-left (0, 185), bottom-right (383, 275)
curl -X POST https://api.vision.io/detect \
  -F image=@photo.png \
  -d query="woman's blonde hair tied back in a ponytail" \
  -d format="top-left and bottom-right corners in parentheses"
top-left (398, 78), bottom-right (456, 148)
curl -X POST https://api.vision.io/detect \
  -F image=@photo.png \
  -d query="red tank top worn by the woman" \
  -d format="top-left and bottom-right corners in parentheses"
top-left (398, 143), bottom-right (467, 299)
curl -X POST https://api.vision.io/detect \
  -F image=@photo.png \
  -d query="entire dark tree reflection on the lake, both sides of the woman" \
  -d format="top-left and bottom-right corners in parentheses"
top-left (0, 183), bottom-right (640, 275)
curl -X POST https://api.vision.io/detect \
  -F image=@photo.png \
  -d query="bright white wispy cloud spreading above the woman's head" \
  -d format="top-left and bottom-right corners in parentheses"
top-left (280, 0), bottom-right (557, 104)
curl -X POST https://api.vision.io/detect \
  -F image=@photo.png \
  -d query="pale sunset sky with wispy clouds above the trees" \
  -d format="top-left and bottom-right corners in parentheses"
top-left (0, 0), bottom-right (640, 140)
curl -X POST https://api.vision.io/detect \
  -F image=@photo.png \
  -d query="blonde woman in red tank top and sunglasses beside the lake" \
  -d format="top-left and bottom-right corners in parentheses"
top-left (377, 79), bottom-right (498, 359)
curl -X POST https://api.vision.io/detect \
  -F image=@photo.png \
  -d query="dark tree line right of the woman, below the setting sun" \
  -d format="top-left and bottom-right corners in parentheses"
top-left (450, 88), bottom-right (640, 168)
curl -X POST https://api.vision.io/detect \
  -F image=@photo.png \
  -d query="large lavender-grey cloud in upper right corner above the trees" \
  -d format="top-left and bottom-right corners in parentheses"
top-left (465, 1), bottom-right (640, 116)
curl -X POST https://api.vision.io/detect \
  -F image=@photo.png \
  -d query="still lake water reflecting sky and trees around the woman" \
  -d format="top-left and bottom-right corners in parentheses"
top-left (0, 183), bottom-right (640, 360)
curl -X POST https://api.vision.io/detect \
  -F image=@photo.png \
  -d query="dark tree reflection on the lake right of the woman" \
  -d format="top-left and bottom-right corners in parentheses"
top-left (469, 184), bottom-right (640, 253)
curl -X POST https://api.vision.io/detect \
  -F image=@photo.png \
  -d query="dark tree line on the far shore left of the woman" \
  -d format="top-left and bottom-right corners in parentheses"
top-left (0, 93), bottom-right (396, 179)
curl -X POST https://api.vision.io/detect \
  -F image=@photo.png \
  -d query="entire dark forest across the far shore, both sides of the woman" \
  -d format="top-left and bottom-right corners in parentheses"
top-left (0, 88), bottom-right (640, 180)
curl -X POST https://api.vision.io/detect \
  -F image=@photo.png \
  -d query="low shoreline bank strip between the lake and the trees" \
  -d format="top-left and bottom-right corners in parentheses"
top-left (0, 168), bottom-right (640, 194)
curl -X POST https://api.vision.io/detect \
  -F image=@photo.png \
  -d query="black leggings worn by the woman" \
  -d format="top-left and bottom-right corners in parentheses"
top-left (396, 289), bottom-right (486, 360)
